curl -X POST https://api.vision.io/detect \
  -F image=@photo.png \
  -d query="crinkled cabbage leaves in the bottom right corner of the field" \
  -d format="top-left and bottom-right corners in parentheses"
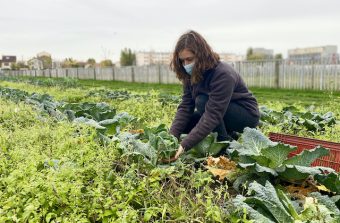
top-left (232, 181), bottom-right (340, 223)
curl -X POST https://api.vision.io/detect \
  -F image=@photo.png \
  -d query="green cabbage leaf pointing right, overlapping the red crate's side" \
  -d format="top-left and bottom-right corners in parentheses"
top-left (283, 147), bottom-right (329, 166)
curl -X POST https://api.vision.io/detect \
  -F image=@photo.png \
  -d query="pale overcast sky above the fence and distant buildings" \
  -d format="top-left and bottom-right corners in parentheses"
top-left (0, 0), bottom-right (340, 61)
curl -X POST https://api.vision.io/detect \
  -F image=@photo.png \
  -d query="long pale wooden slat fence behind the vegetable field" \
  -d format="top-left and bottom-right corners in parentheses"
top-left (5, 60), bottom-right (340, 90)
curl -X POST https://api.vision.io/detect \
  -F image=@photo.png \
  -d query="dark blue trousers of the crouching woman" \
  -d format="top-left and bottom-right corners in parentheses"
top-left (184, 94), bottom-right (259, 141)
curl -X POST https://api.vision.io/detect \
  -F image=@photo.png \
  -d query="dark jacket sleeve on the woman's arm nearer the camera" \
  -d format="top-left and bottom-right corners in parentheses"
top-left (181, 70), bottom-right (237, 150)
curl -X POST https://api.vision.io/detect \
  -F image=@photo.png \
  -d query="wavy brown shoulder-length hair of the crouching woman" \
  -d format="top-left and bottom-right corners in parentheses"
top-left (170, 30), bottom-right (220, 84)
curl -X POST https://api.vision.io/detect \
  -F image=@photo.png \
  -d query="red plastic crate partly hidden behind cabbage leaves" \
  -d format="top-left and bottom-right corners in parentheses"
top-left (269, 132), bottom-right (340, 172)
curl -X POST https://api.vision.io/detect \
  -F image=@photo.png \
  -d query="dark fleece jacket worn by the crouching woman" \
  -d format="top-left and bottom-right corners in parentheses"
top-left (170, 62), bottom-right (260, 150)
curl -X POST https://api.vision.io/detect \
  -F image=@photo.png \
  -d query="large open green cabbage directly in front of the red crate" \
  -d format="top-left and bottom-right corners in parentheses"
top-left (228, 128), bottom-right (334, 182)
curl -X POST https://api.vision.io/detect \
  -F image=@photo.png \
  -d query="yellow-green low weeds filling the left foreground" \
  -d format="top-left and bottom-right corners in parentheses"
top-left (0, 99), bottom-right (228, 222)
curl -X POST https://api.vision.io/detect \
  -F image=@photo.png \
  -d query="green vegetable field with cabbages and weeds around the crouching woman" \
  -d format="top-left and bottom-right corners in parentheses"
top-left (0, 77), bottom-right (340, 223)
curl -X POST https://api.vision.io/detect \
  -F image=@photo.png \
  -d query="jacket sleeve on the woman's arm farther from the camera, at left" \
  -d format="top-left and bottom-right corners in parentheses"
top-left (170, 80), bottom-right (195, 139)
